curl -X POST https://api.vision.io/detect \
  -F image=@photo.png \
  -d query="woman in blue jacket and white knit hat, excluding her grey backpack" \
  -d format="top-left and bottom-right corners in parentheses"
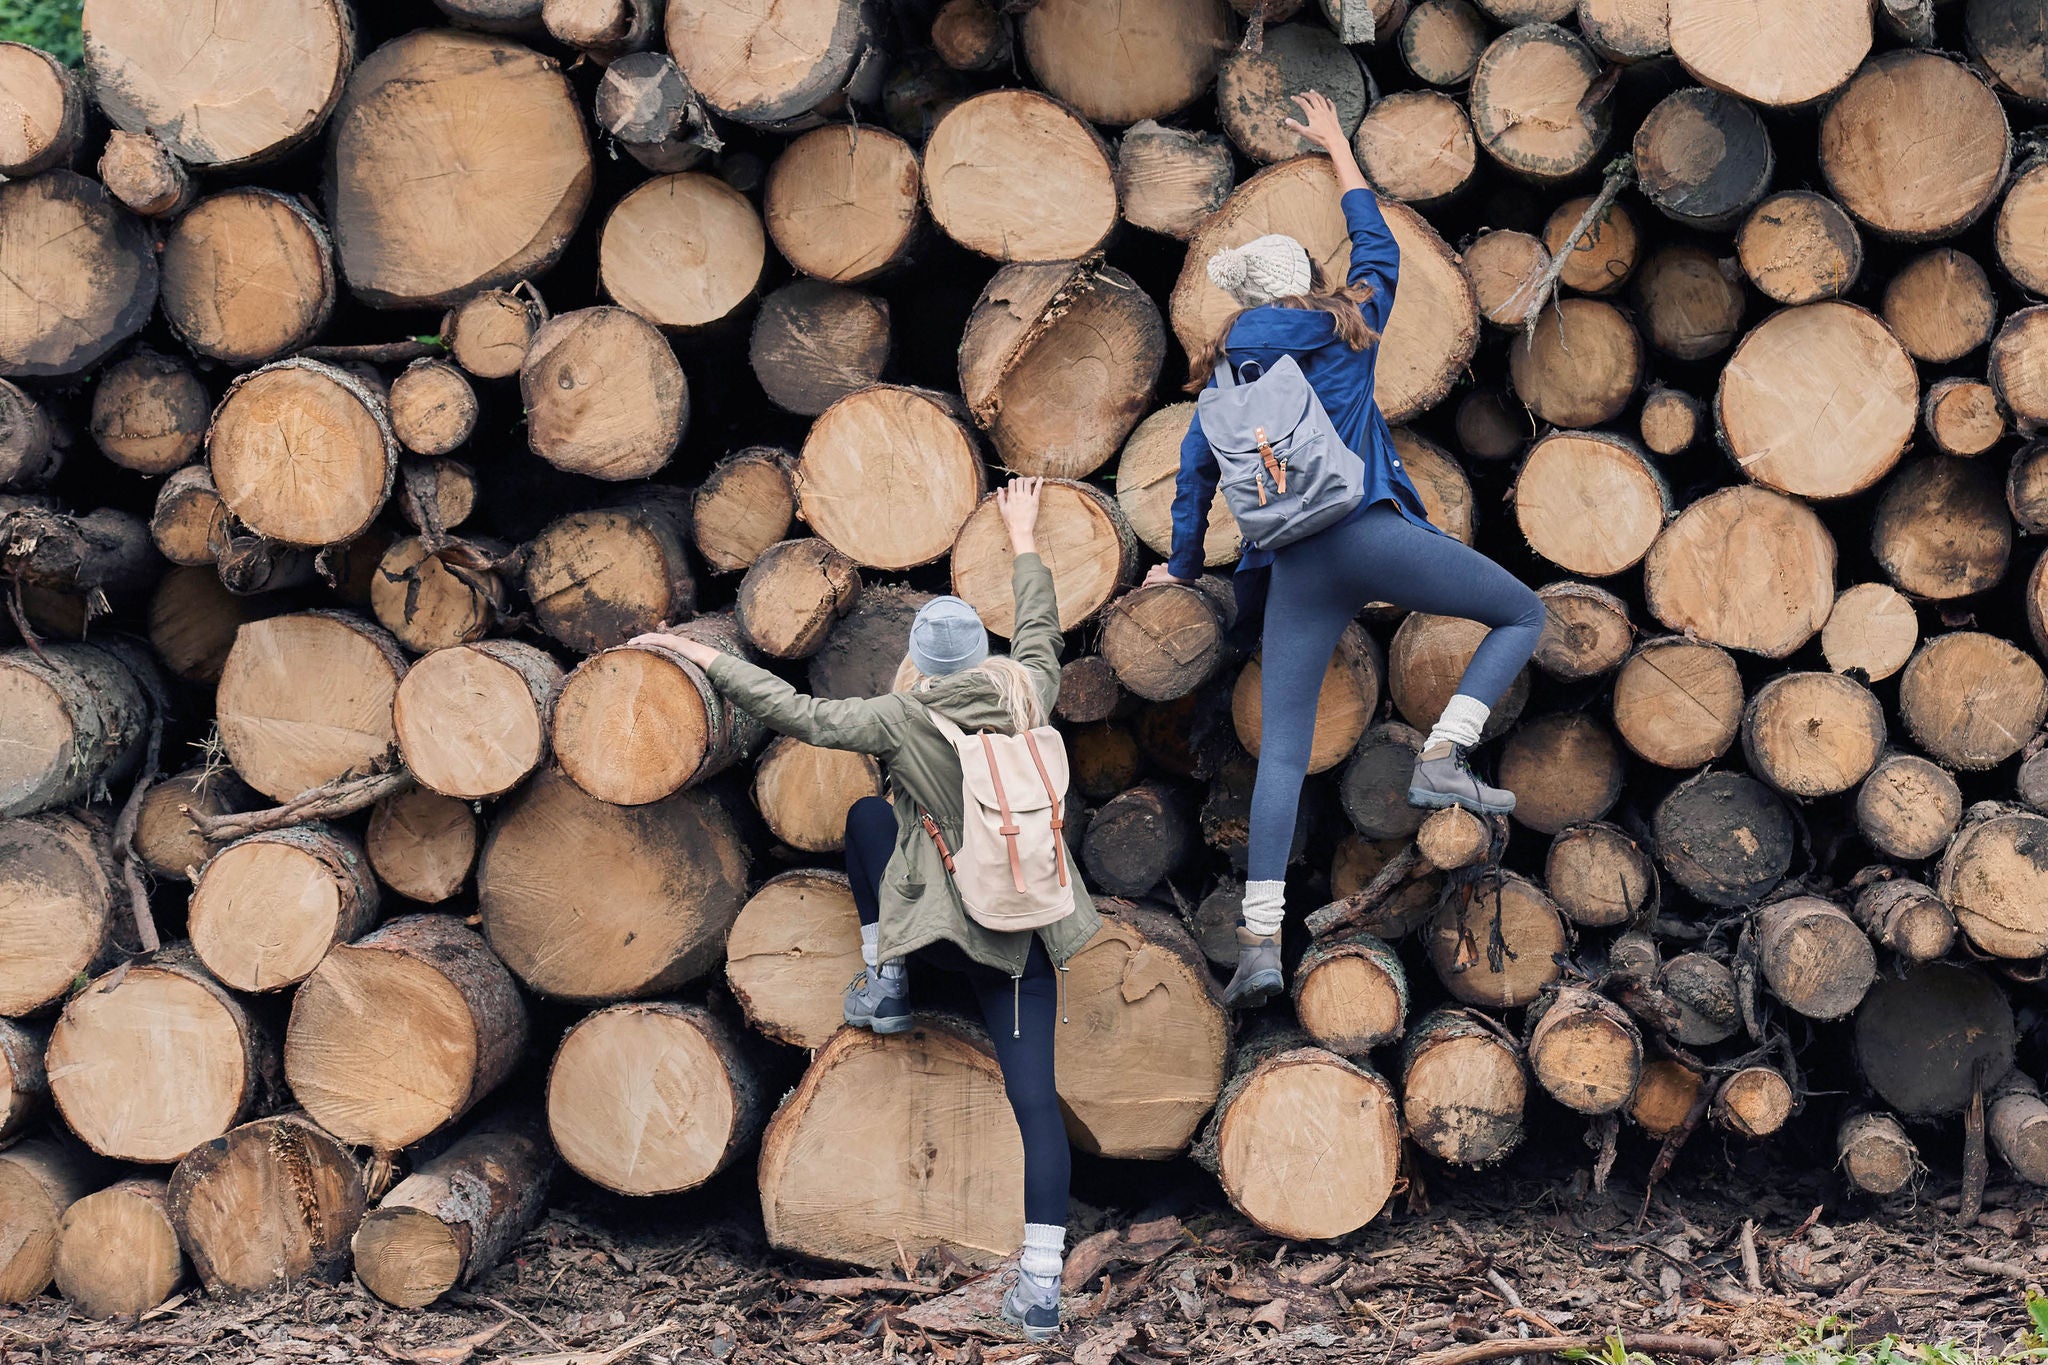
top-left (1147, 90), bottom-right (1544, 1009)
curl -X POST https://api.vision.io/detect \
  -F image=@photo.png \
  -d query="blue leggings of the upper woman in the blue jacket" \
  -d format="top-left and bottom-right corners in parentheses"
top-left (1249, 501), bottom-right (1544, 882)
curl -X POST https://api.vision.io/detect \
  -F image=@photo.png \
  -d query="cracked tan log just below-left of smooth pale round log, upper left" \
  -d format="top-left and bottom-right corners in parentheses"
top-left (518, 304), bottom-right (690, 483)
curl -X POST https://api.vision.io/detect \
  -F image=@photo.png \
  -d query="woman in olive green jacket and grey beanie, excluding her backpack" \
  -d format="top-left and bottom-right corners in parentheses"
top-left (635, 479), bottom-right (1100, 1340)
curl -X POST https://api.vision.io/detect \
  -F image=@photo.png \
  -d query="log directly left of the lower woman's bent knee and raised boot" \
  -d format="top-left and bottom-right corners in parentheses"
top-left (725, 868), bottom-right (862, 1050)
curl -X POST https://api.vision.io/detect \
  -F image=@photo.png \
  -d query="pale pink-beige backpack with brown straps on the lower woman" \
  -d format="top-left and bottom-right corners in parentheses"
top-left (918, 708), bottom-right (1073, 933)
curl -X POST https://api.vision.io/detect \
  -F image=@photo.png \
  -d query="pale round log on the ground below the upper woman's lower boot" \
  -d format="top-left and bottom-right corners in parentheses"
top-left (1194, 1031), bottom-right (1401, 1240)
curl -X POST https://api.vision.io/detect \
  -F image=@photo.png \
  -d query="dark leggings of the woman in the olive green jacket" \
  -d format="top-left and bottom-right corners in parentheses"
top-left (846, 796), bottom-right (1073, 1226)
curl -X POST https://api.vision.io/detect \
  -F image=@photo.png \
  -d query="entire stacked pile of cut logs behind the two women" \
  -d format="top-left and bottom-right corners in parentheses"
top-left (0, 0), bottom-right (2048, 1314)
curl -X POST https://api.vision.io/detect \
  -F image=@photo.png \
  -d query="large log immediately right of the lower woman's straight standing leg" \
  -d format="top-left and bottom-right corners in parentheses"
top-left (1053, 905), bottom-right (1231, 1160)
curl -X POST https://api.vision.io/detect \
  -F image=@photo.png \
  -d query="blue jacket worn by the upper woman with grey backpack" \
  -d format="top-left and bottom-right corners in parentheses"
top-left (1167, 190), bottom-right (1434, 579)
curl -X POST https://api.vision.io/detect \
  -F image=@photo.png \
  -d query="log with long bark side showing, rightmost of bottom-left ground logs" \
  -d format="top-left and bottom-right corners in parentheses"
top-left (348, 1113), bottom-right (555, 1308)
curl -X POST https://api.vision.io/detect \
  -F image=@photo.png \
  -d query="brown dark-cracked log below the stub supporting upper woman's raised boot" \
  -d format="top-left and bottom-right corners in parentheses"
top-left (1427, 872), bottom-right (1565, 1009)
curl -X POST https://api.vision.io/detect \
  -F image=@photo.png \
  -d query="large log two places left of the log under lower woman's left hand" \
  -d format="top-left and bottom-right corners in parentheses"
top-left (215, 612), bottom-right (406, 800)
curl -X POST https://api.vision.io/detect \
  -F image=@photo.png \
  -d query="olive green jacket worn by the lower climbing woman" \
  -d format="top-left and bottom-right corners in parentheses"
top-left (707, 555), bottom-right (1100, 976)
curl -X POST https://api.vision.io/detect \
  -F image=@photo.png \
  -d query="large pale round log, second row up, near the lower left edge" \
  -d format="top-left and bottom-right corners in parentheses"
top-left (45, 945), bottom-right (276, 1162)
